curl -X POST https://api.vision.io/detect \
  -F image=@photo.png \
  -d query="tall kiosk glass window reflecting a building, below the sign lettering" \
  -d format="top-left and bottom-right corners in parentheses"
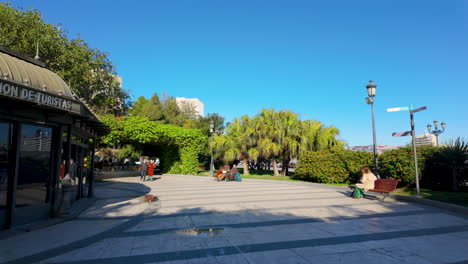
top-left (16, 124), bottom-right (52, 207)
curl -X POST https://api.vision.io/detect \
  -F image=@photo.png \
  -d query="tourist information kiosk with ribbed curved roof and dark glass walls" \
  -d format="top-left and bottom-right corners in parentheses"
top-left (0, 46), bottom-right (109, 229)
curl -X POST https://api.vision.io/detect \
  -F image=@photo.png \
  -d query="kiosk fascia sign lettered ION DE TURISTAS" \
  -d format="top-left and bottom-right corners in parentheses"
top-left (0, 80), bottom-right (73, 111)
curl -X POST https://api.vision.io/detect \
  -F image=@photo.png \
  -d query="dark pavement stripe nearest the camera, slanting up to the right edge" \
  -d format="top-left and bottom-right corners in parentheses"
top-left (42, 225), bottom-right (468, 264)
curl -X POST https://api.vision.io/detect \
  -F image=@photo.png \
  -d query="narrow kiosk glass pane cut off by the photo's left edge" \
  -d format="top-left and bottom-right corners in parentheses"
top-left (0, 122), bottom-right (11, 211)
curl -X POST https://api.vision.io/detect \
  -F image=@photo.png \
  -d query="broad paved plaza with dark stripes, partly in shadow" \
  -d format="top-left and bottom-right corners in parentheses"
top-left (0, 175), bottom-right (468, 264)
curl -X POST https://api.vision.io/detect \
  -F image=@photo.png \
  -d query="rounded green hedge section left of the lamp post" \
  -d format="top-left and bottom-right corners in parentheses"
top-left (295, 150), bottom-right (373, 183)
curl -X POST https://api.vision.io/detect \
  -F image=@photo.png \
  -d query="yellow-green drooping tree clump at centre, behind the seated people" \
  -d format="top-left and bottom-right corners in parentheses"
top-left (211, 109), bottom-right (344, 175)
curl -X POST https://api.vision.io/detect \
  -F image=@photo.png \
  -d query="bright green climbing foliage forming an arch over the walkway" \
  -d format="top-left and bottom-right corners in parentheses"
top-left (101, 115), bottom-right (208, 174)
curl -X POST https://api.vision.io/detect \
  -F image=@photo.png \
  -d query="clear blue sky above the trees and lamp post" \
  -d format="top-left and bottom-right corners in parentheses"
top-left (8, 0), bottom-right (468, 145)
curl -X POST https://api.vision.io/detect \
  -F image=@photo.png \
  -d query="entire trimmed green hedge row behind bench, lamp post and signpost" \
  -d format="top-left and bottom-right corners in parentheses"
top-left (295, 146), bottom-right (446, 187)
